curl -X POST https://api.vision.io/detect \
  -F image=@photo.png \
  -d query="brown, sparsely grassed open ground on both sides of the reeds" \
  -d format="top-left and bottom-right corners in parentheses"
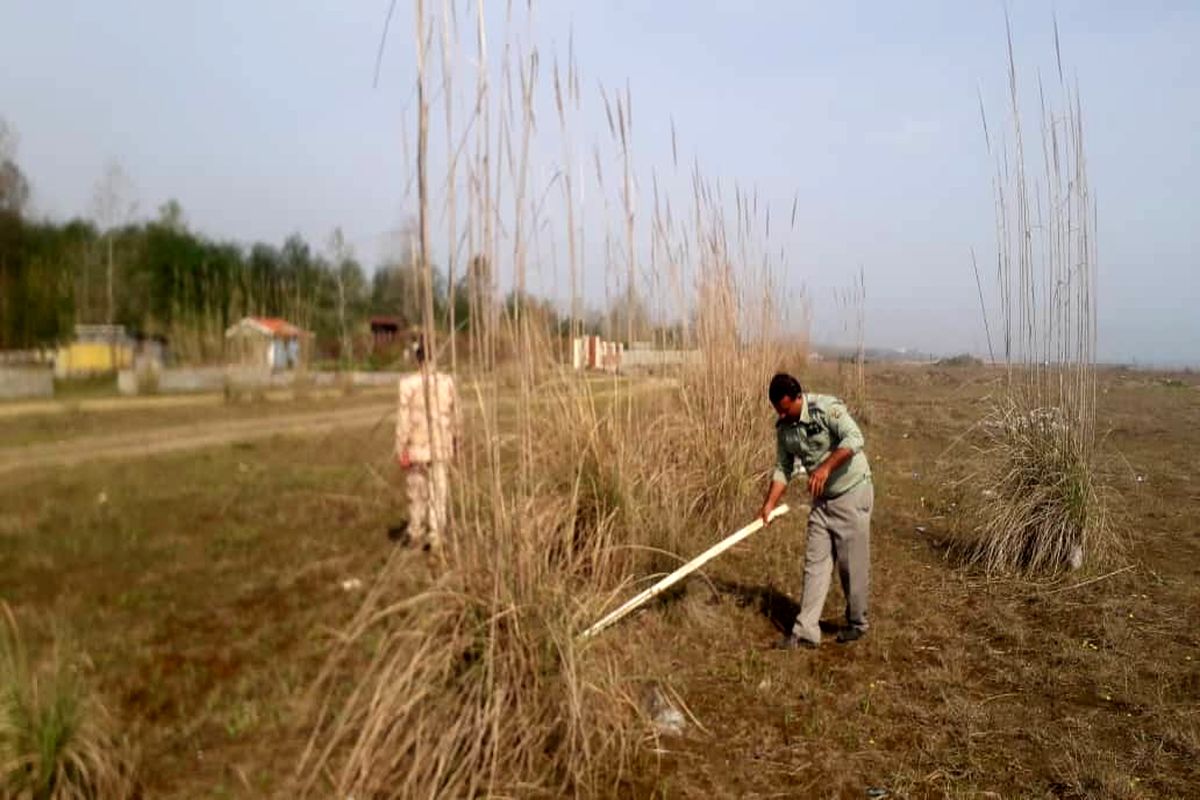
top-left (0, 366), bottom-right (1200, 798)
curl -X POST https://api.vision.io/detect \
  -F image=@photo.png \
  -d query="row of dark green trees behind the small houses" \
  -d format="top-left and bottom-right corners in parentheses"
top-left (0, 120), bottom-right (679, 361)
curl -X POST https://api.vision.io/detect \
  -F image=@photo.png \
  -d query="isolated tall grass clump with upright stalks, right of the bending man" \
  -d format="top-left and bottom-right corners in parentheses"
top-left (953, 20), bottom-right (1121, 575)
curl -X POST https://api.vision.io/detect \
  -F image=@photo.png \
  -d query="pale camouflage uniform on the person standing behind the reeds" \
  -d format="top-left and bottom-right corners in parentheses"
top-left (396, 369), bottom-right (458, 547)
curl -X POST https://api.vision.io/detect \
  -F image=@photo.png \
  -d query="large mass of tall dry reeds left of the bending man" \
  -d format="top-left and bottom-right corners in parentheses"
top-left (298, 0), bottom-right (794, 798)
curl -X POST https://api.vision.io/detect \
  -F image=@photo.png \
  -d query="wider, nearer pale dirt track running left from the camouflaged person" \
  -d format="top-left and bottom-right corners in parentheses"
top-left (0, 398), bottom-right (394, 475)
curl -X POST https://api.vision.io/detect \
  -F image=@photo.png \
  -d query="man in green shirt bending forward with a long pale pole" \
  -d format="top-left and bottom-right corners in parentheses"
top-left (761, 373), bottom-right (875, 649)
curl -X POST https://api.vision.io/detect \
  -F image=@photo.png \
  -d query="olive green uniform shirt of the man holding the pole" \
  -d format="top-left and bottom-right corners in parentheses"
top-left (773, 395), bottom-right (871, 498)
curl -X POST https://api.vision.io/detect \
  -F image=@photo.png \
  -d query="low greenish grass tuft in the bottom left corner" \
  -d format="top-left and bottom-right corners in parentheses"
top-left (0, 604), bottom-right (136, 800)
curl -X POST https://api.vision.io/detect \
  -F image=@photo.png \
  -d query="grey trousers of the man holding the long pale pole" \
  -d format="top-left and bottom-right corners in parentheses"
top-left (792, 480), bottom-right (875, 644)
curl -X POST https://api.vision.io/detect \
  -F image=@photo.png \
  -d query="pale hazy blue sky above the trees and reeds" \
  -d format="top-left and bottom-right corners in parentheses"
top-left (0, 0), bottom-right (1200, 363)
